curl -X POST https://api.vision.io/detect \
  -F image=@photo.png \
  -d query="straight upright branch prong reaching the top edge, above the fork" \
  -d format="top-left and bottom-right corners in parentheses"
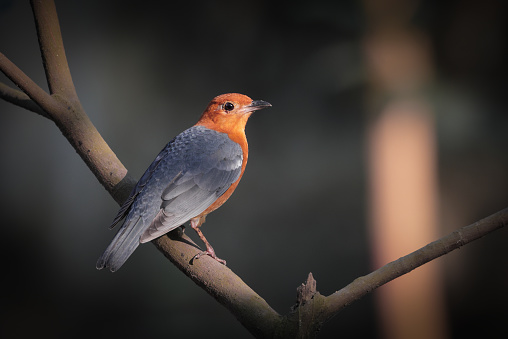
top-left (31, 0), bottom-right (78, 102)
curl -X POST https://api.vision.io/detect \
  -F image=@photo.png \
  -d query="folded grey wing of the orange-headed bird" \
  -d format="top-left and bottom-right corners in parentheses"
top-left (140, 130), bottom-right (243, 243)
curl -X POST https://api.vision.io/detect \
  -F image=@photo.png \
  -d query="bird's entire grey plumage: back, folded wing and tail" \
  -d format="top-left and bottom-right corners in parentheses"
top-left (97, 126), bottom-right (243, 271)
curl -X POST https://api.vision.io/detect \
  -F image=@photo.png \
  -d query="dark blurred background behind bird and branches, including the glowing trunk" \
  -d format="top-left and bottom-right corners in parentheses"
top-left (0, 0), bottom-right (508, 338)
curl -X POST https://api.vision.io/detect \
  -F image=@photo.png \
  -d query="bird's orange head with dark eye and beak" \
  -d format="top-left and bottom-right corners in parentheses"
top-left (197, 93), bottom-right (272, 134)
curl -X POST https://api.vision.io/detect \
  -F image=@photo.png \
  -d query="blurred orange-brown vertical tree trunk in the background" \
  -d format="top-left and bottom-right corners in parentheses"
top-left (364, 1), bottom-right (447, 338)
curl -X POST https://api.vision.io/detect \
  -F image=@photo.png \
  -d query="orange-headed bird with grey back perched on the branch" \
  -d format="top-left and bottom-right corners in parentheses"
top-left (96, 93), bottom-right (272, 272)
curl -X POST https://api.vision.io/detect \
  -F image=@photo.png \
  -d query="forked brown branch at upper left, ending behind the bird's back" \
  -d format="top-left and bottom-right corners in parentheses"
top-left (0, 0), bottom-right (135, 203)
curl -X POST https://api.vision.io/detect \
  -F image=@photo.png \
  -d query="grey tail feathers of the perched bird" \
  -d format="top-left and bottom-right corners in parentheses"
top-left (96, 217), bottom-right (143, 272)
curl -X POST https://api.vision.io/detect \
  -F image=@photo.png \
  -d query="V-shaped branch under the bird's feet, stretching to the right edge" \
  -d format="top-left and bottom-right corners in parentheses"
top-left (154, 208), bottom-right (508, 338)
